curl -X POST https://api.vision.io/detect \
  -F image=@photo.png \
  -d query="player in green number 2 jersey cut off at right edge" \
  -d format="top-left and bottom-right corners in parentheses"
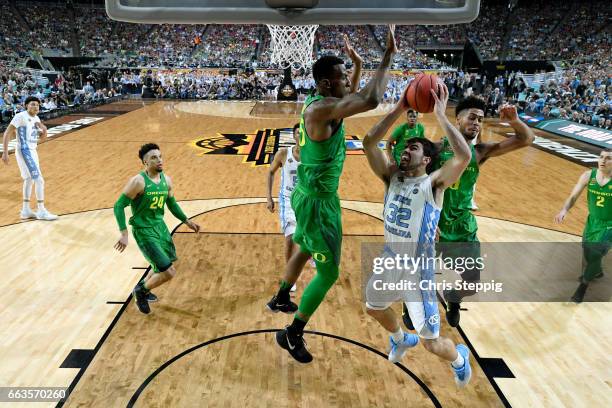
top-left (555, 149), bottom-right (612, 303)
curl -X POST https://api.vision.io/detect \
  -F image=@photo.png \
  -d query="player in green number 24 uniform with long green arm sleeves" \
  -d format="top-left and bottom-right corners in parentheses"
top-left (114, 143), bottom-right (200, 314)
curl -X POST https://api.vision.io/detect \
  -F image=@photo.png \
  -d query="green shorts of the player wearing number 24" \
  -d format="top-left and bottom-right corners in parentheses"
top-left (132, 223), bottom-right (177, 273)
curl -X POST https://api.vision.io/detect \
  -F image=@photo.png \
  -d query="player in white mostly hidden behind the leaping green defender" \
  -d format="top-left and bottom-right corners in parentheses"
top-left (267, 123), bottom-right (300, 300)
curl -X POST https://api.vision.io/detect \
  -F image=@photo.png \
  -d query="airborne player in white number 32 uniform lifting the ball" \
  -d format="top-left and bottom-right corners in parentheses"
top-left (363, 82), bottom-right (471, 386)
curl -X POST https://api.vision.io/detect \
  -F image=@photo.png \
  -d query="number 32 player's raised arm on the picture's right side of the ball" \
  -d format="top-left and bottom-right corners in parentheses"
top-left (431, 82), bottom-right (472, 190)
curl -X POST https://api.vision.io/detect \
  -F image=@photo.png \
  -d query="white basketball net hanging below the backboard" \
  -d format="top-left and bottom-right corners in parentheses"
top-left (268, 25), bottom-right (319, 69)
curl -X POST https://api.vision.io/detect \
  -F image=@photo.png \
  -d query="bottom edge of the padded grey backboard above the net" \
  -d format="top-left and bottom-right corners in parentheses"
top-left (106, 0), bottom-right (480, 25)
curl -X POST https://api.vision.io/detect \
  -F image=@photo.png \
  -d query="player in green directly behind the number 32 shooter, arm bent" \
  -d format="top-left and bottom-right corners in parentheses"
top-left (404, 96), bottom-right (535, 327)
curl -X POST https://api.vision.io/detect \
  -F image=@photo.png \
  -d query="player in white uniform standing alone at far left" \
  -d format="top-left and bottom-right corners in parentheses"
top-left (2, 96), bottom-right (57, 221)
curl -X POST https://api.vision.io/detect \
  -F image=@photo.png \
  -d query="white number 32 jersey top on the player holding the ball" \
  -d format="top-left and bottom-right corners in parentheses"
top-left (383, 172), bottom-right (440, 256)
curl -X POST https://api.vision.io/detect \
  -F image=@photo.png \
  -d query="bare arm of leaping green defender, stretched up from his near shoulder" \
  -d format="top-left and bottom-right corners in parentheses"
top-left (309, 25), bottom-right (397, 121)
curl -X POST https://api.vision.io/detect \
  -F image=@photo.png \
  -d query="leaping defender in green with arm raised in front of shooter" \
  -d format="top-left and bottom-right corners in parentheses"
top-left (267, 26), bottom-right (396, 363)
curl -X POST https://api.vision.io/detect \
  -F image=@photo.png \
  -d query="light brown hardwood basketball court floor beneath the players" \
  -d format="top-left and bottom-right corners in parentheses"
top-left (0, 102), bottom-right (612, 407)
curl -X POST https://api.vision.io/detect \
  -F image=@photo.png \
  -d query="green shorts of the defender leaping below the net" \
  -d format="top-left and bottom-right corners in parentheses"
top-left (291, 187), bottom-right (342, 265)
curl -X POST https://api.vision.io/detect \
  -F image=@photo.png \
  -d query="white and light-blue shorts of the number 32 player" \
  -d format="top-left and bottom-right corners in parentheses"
top-left (366, 256), bottom-right (440, 339)
